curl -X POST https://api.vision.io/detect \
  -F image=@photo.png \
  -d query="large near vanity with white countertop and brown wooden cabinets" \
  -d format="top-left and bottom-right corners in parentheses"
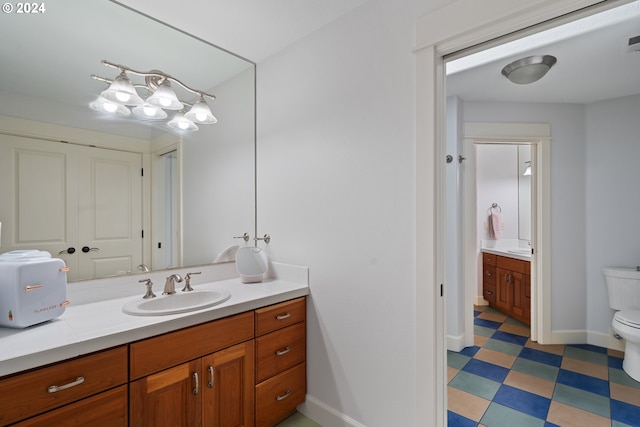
top-left (0, 264), bottom-right (308, 427)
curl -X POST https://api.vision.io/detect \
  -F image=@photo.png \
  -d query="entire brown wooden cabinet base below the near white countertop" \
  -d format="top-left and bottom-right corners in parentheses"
top-left (0, 297), bottom-right (306, 427)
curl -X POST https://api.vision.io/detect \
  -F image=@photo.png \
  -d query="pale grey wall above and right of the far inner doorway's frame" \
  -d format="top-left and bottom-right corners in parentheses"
top-left (464, 102), bottom-right (587, 331)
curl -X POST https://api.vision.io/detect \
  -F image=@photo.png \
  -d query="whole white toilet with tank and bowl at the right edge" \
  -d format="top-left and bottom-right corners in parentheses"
top-left (604, 267), bottom-right (640, 381)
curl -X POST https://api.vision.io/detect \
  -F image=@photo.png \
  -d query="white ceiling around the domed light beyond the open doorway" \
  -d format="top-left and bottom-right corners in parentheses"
top-left (447, 1), bottom-right (640, 104)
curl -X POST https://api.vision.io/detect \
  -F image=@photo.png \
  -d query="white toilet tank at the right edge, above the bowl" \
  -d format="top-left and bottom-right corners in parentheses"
top-left (603, 267), bottom-right (640, 310)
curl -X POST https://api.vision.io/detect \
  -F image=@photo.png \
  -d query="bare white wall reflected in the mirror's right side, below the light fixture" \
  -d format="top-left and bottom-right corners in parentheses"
top-left (182, 69), bottom-right (255, 265)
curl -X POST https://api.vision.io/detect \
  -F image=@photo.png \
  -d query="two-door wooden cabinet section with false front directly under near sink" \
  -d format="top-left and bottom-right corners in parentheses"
top-left (130, 312), bottom-right (254, 427)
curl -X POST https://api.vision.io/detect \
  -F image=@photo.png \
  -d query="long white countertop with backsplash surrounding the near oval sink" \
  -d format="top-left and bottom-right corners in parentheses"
top-left (0, 264), bottom-right (309, 376)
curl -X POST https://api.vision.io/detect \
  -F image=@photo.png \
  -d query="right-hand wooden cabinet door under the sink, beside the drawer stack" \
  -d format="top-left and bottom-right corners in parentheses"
top-left (202, 340), bottom-right (255, 427)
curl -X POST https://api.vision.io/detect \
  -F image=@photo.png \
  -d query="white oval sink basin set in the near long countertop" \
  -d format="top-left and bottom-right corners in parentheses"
top-left (122, 290), bottom-right (231, 316)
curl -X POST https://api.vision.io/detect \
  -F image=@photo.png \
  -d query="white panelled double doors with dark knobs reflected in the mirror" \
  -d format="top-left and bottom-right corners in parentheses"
top-left (0, 135), bottom-right (142, 280)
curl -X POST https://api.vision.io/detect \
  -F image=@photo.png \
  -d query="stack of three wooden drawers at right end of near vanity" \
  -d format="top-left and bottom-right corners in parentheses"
top-left (255, 298), bottom-right (307, 427)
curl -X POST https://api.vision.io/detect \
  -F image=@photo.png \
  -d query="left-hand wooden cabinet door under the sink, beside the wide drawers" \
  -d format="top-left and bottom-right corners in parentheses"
top-left (129, 360), bottom-right (202, 427)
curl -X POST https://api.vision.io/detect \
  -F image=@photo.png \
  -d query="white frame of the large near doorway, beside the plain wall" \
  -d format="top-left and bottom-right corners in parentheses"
top-left (414, 0), bottom-right (632, 426)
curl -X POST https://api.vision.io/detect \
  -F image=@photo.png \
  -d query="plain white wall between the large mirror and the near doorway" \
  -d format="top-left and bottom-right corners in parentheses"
top-left (257, 0), bottom-right (450, 427)
